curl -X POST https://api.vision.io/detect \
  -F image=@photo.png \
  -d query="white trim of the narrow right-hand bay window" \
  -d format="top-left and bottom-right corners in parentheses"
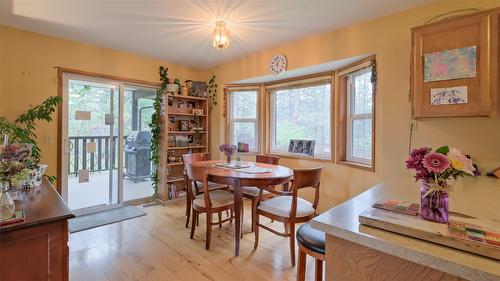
top-left (346, 66), bottom-right (374, 166)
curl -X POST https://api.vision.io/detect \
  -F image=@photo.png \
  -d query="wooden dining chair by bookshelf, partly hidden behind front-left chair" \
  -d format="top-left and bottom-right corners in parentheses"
top-left (182, 152), bottom-right (227, 228)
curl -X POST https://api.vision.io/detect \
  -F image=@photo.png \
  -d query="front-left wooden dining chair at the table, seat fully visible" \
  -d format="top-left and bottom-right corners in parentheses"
top-left (185, 164), bottom-right (234, 250)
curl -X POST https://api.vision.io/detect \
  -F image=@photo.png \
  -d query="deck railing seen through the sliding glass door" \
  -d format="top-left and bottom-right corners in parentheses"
top-left (68, 136), bottom-right (118, 174)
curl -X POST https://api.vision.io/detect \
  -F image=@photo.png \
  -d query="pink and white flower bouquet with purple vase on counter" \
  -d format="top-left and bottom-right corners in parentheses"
top-left (405, 146), bottom-right (480, 223)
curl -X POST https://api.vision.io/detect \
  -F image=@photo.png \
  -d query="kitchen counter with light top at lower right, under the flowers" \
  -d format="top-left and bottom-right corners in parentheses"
top-left (311, 175), bottom-right (500, 281)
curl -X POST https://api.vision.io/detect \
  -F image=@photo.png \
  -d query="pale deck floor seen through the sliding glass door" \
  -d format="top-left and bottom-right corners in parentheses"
top-left (68, 170), bottom-right (153, 210)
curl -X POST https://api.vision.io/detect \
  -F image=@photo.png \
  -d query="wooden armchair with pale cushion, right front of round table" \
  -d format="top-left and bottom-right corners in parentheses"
top-left (254, 166), bottom-right (323, 266)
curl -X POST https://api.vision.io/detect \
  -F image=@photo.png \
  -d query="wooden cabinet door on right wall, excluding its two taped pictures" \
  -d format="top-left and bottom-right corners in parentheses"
top-left (411, 13), bottom-right (498, 118)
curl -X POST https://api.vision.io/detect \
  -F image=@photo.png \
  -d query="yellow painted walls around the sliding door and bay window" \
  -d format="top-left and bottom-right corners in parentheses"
top-left (0, 0), bottom-right (500, 210)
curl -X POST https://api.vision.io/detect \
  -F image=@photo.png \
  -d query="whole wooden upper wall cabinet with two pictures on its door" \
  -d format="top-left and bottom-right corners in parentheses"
top-left (410, 9), bottom-right (500, 118)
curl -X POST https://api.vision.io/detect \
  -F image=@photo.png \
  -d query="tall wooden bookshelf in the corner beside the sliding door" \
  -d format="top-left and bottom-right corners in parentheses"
top-left (158, 93), bottom-right (209, 202)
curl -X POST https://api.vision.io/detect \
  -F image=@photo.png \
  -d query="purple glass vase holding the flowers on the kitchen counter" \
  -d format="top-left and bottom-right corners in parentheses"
top-left (420, 183), bottom-right (450, 223)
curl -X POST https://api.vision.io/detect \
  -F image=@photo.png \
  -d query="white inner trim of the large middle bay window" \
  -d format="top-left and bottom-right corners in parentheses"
top-left (266, 81), bottom-right (334, 161)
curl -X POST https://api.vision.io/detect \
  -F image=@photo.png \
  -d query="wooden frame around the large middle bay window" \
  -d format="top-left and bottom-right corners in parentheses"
top-left (264, 75), bottom-right (336, 163)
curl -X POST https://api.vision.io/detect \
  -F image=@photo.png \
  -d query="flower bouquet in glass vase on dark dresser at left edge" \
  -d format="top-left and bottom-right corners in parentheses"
top-left (0, 141), bottom-right (33, 221)
